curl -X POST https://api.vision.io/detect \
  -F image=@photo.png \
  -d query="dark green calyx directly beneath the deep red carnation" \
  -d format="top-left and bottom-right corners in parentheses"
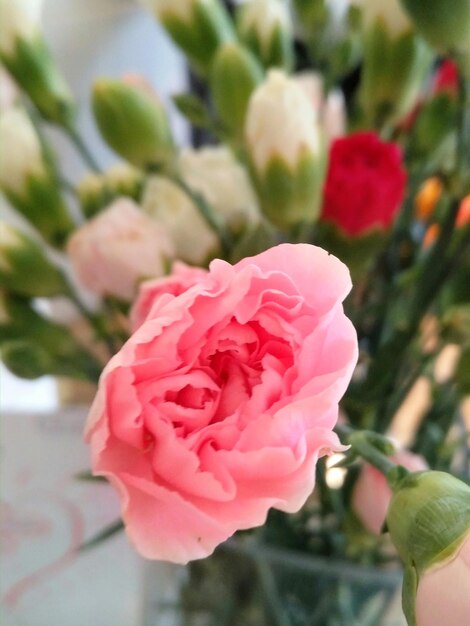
top-left (314, 220), bottom-right (389, 283)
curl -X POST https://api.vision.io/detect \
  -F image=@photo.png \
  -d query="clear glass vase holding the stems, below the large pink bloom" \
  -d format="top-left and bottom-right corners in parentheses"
top-left (140, 541), bottom-right (406, 626)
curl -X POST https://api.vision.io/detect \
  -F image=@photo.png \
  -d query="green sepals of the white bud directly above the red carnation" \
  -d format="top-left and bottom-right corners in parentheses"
top-left (359, 19), bottom-right (433, 128)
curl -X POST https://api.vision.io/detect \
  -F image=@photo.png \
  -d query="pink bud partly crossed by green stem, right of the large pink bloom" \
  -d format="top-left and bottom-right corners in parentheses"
top-left (352, 450), bottom-right (428, 535)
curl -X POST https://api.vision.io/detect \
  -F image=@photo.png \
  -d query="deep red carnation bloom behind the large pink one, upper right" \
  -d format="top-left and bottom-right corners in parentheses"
top-left (322, 132), bottom-right (406, 236)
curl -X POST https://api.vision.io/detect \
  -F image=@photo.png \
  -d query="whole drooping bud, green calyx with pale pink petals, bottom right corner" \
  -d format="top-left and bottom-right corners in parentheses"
top-left (387, 471), bottom-right (470, 626)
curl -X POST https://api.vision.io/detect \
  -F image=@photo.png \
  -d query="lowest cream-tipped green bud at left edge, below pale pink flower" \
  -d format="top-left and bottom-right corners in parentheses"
top-left (0, 222), bottom-right (67, 297)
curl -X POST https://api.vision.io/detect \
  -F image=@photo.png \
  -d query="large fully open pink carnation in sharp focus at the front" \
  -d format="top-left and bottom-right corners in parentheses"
top-left (86, 244), bottom-right (357, 563)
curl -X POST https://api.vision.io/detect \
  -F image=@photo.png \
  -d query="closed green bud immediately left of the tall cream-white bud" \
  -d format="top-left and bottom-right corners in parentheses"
top-left (211, 43), bottom-right (263, 143)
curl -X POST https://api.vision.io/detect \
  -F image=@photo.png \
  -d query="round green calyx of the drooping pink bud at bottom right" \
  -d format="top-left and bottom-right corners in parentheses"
top-left (387, 471), bottom-right (470, 625)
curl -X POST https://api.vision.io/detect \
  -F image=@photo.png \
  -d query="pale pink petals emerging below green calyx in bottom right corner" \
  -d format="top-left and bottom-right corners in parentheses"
top-left (416, 534), bottom-right (470, 626)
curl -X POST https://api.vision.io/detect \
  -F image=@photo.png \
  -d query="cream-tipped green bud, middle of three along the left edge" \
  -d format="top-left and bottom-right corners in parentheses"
top-left (0, 107), bottom-right (74, 247)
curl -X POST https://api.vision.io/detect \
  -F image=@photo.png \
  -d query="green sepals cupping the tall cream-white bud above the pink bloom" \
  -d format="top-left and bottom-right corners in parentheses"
top-left (250, 150), bottom-right (326, 230)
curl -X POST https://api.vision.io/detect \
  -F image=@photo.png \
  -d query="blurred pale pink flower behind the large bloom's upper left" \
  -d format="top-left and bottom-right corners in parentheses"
top-left (67, 198), bottom-right (172, 300)
